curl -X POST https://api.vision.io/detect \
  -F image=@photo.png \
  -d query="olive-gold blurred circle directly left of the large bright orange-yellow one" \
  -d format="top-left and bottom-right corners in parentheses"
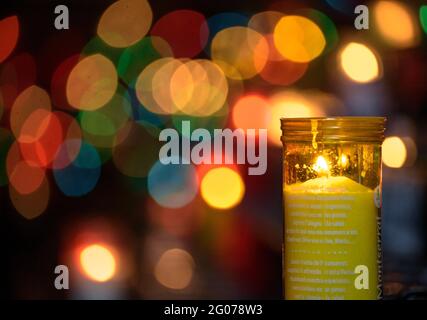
top-left (211, 27), bottom-right (268, 79)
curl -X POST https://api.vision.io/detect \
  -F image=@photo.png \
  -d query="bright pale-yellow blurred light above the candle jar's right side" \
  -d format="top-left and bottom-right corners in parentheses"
top-left (340, 42), bottom-right (380, 83)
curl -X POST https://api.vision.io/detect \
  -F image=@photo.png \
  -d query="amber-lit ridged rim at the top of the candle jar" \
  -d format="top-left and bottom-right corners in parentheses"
top-left (280, 116), bottom-right (387, 143)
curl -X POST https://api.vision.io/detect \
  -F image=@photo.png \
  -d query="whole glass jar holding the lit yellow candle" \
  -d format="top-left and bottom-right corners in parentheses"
top-left (281, 117), bottom-right (385, 300)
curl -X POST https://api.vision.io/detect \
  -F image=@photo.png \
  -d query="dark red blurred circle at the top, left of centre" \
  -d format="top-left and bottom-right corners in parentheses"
top-left (151, 10), bottom-right (209, 58)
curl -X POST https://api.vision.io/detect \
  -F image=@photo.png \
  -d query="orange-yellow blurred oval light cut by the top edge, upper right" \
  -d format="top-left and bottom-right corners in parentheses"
top-left (374, 1), bottom-right (419, 48)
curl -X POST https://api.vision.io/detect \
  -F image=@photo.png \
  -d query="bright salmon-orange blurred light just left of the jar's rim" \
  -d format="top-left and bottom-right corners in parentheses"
top-left (232, 94), bottom-right (271, 129)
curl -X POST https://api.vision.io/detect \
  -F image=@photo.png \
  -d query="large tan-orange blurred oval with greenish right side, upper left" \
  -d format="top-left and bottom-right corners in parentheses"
top-left (66, 54), bottom-right (118, 111)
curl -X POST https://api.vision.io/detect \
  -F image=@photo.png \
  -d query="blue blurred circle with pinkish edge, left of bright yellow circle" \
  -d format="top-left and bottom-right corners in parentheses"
top-left (147, 158), bottom-right (198, 208)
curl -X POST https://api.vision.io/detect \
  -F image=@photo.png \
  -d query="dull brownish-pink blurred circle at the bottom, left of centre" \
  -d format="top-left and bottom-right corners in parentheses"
top-left (154, 248), bottom-right (194, 290)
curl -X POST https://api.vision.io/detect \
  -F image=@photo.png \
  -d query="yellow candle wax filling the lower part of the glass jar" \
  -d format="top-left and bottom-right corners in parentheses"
top-left (284, 177), bottom-right (381, 300)
